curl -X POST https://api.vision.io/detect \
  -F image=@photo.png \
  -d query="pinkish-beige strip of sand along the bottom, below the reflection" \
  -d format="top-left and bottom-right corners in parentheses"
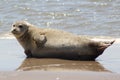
top-left (0, 71), bottom-right (120, 80)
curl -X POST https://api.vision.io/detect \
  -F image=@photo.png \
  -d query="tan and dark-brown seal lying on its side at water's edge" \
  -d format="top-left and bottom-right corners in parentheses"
top-left (11, 21), bottom-right (114, 60)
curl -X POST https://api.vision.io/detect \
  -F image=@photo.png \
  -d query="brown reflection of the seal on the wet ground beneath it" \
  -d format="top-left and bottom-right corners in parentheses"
top-left (17, 58), bottom-right (107, 72)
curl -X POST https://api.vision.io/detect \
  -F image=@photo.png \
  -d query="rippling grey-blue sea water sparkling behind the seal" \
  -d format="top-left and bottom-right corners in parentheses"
top-left (0, 0), bottom-right (120, 37)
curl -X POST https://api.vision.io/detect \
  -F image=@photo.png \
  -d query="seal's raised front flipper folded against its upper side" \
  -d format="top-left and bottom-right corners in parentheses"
top-left (34, 34), bottom-right (47, 48)
